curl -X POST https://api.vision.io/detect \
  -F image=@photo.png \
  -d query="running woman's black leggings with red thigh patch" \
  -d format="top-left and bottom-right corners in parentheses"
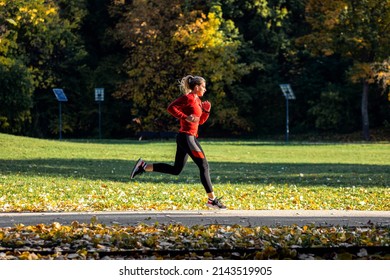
top-left (153, 133), bottom-right (213, 193)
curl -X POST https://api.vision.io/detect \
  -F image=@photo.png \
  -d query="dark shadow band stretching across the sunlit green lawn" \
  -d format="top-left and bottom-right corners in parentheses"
top-left (0, 159), bottom-right (390, 187)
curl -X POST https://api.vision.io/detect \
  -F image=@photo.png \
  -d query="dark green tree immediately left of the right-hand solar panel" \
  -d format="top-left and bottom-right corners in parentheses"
top-left (212, 0), bottom-right (299, 136)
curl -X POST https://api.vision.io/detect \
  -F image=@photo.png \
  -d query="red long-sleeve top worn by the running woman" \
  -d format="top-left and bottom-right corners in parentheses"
top-left (168, 93), bottom-right (209, 137)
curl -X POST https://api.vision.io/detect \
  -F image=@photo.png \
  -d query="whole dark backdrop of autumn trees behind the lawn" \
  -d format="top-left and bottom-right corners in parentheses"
top-left (0, 0), bottom-right (390, 140)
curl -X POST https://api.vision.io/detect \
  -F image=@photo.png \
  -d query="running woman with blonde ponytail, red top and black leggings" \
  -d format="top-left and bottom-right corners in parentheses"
top-left (131, 75), bottom-right (226, 210)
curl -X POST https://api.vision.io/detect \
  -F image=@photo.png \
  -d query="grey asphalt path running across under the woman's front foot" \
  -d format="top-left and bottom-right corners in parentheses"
top-left (0, 210), bottom-right (390, 227)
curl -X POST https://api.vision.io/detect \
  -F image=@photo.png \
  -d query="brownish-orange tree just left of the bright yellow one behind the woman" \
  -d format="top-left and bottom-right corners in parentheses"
top-left (111, 0), bottom-right (186, 131)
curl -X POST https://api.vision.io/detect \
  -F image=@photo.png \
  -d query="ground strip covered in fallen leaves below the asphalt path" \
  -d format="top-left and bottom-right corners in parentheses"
top-left (0, 221), bottom-right (390, 260)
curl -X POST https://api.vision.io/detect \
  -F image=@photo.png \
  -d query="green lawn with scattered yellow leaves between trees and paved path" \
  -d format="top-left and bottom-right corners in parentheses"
top-left (0, 134), bottom-right (390, 212)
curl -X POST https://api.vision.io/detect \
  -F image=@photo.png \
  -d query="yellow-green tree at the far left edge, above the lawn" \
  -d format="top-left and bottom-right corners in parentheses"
top-left (0, 0), bottom-right (85, 136)
